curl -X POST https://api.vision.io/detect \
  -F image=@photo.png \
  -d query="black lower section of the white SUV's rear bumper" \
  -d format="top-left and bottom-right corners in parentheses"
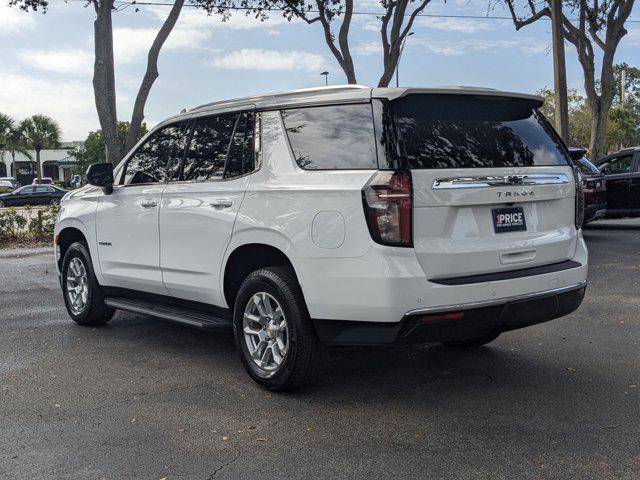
top-left (313, 280), bottom-right (587, 345)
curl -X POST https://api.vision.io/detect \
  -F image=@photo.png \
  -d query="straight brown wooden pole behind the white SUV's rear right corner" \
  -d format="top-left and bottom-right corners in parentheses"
top-left (551, 0), bottom-right (569, 142)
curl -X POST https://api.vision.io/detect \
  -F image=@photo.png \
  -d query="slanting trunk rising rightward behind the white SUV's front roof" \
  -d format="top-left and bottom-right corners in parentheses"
top-left (123, 0), bottom-right (184, 154)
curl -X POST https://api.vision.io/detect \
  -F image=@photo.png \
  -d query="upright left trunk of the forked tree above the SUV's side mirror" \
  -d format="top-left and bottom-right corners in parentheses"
top-left (93, 0), bottom-right (124, 165)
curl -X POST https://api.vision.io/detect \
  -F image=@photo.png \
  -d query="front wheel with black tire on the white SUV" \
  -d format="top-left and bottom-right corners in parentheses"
top-left (62, 242), bottom-right (115, 326)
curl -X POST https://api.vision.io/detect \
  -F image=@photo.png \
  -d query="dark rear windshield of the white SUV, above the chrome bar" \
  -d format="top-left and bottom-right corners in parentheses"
top-left (391, 94), bottom-right (567, 169)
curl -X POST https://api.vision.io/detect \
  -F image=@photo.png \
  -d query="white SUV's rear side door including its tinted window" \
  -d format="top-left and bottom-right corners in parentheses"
top-left (160, 112), bottom-right (255, 305)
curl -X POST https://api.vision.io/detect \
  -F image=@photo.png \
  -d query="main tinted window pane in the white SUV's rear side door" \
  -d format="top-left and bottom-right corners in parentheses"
top-left (182, 113), bottom-right (238, 182)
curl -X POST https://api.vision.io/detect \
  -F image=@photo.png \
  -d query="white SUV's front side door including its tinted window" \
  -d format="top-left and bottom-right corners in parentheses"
top-left (96, 123), bottom-right (184, 294)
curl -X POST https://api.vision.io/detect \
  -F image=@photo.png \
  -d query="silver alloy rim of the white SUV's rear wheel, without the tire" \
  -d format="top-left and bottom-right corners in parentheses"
top-left (242, 292), bottom-right (289, 373)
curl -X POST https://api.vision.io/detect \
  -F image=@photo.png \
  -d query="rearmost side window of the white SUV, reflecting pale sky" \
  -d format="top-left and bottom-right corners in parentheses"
top-left (282, 104), bottom-right (377, 170)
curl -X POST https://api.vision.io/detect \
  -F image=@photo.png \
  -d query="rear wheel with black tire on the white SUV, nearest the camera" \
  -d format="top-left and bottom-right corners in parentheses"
top-left (233, 267), bottom-right (322, 391)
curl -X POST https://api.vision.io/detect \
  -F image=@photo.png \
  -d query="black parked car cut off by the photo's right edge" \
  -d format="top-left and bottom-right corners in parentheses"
top-left (595, 147), bottom-right (640, 218)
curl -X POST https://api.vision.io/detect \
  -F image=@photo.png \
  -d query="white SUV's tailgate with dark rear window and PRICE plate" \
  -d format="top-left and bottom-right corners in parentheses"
top-left (391, 94), bottom-right (577, 280)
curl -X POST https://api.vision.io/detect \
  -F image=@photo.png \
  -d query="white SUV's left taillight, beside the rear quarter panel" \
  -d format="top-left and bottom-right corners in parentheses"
top-left (362, 171), bottom-right (413, 247)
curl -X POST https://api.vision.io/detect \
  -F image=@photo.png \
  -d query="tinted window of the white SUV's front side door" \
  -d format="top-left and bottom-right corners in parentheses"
top-left (122, 125), bottom-right (184, 185)
